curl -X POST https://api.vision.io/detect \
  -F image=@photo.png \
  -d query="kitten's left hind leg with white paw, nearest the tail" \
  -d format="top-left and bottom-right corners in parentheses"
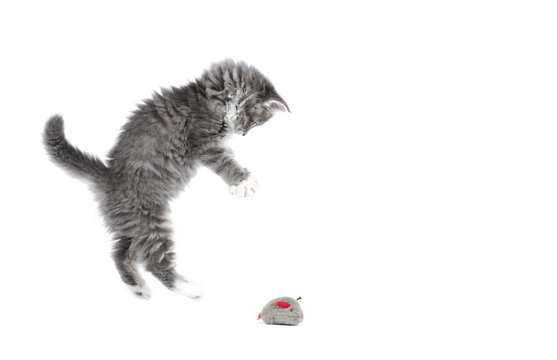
top-left (112, 236), bottom-right (151, 299)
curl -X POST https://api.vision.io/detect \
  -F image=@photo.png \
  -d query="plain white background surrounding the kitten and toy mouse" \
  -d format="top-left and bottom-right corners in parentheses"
top-left (0, 1), bottom-right (557, 359)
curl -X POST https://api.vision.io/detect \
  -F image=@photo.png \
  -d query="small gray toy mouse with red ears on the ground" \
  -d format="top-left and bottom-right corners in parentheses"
top-left (257, 297), bottom-right (304, 325)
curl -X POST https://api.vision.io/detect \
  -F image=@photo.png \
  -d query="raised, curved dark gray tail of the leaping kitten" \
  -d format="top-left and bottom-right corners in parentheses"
top-left (43, 115), bottom-right (108, 182)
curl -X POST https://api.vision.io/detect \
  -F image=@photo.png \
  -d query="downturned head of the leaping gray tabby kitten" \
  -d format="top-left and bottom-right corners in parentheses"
top-left (201, 60), bottom-right (290, 135)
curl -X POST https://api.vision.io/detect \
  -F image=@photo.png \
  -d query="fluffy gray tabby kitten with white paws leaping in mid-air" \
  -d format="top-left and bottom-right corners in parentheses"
top-left (44, 60), bottom-right (289, 298)
